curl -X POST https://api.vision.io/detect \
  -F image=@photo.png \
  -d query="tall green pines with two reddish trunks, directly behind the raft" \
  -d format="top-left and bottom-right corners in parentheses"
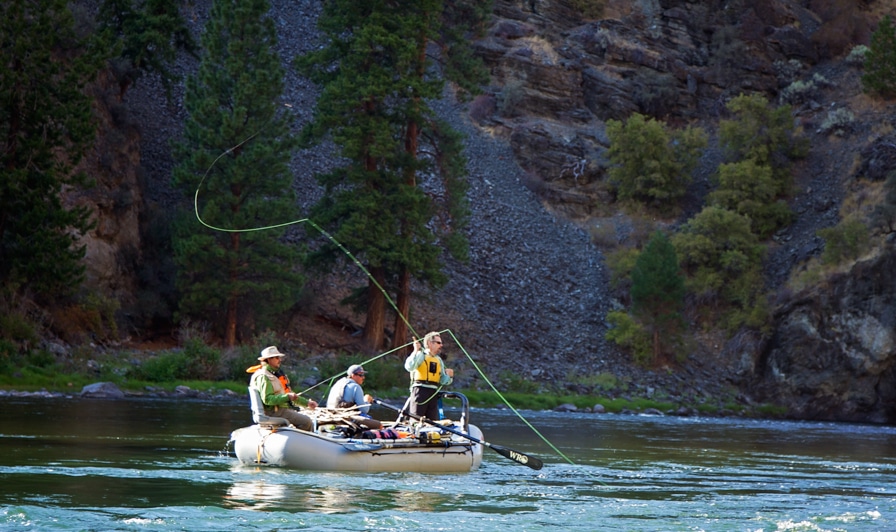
top-left (297, 0), bottom-right (485, 350)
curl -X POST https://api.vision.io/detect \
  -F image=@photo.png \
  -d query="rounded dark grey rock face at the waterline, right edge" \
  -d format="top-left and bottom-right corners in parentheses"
top-left (753, 247), bottom-right (896, 423)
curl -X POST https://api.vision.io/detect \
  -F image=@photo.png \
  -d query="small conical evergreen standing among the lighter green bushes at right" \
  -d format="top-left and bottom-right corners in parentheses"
top-left (631, 231), bottom-right (685, 360)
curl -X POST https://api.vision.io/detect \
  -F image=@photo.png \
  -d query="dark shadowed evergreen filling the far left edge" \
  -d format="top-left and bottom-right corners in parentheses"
top-left (0, 0), bottom-right (106, 297)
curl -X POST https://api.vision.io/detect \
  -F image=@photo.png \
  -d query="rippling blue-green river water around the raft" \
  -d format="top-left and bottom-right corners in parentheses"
top-left (0, 397), bottom-right (896, 531)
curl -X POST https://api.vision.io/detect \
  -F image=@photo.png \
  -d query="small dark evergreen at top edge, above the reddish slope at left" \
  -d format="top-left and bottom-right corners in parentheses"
top-left (99, 0), bottom-right (196, 98)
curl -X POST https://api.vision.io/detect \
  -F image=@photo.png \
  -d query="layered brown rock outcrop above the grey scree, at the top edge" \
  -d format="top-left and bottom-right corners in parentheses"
top-left (475, 0), bottom-right (869, 218)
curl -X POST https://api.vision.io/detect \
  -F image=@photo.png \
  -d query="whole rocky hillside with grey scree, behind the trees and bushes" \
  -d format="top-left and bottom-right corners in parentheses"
top-left (73, 0), bottom-right (896, 422)
